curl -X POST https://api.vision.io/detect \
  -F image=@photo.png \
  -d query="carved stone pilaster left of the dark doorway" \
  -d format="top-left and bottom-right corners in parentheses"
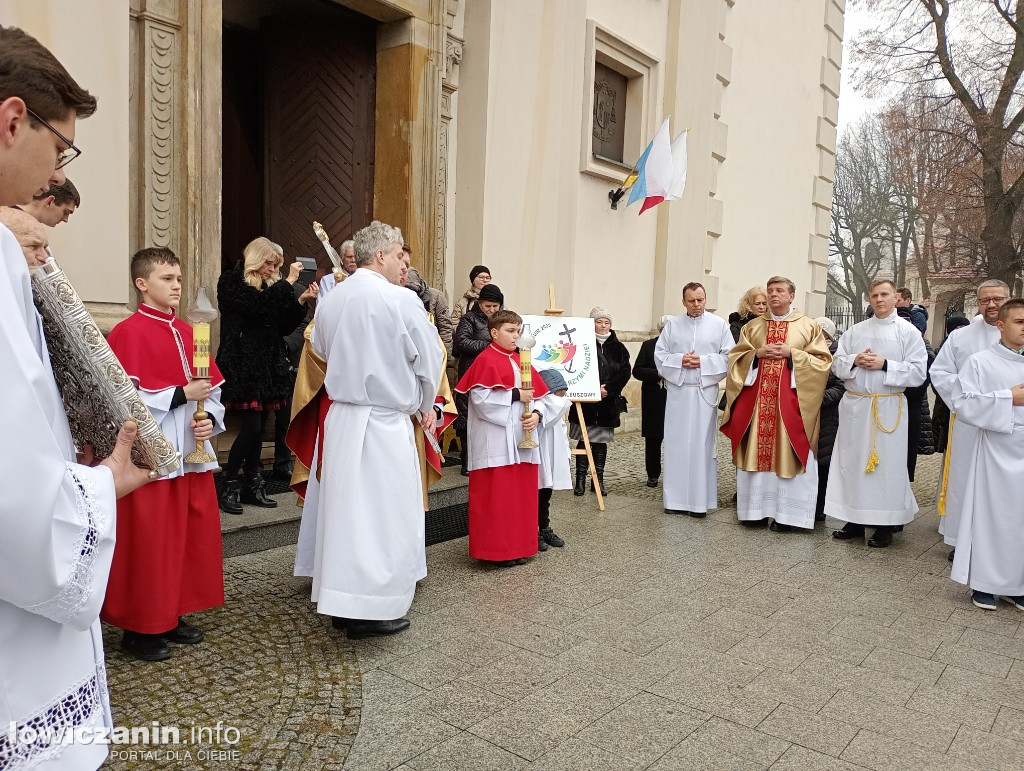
top-left (126, 0), bottom-right (222, 327)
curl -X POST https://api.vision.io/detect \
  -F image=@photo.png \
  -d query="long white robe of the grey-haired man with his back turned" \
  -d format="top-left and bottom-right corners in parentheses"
top-left (312, 268), bottom-right (443, 620)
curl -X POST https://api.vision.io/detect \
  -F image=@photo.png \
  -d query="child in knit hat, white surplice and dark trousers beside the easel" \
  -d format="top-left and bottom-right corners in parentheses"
top-left (537, 368), bottom-right (572, 552)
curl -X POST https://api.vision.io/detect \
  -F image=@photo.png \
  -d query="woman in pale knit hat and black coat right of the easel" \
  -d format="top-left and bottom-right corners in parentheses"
top-left (569, 307), bottom-right (630, 496)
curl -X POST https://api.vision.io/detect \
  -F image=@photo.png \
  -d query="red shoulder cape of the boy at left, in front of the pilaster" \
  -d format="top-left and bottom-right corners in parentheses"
top-left (106, 305), bottom-right (224, 391)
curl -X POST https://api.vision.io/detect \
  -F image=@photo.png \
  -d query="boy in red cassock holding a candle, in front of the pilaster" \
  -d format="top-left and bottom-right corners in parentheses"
top-left (100, 248), bottom-right (224, 661)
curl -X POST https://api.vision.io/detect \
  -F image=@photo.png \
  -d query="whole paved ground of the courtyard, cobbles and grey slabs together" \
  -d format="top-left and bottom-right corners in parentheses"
top-left (101, 437), bottom-right (1024, 771)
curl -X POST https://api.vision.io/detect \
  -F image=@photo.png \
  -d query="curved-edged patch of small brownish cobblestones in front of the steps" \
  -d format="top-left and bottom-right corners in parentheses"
top-left (103, 547), bottom-right (361, 771)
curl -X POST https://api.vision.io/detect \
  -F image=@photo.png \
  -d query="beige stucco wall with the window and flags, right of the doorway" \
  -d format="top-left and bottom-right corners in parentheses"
top-left (449, 0), bottom-right (844, 333)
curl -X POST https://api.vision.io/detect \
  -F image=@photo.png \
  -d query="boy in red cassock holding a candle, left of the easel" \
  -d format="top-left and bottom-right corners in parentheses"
top-left (456, 310), bottom-right (548, 566)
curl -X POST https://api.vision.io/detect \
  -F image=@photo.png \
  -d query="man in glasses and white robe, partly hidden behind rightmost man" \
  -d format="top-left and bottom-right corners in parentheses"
top-left (929, 279), bottom-right (1010, 560)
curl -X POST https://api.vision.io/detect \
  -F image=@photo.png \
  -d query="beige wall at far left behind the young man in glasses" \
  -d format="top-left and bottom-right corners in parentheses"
top-left (0, 0), bottom-right (129, 303)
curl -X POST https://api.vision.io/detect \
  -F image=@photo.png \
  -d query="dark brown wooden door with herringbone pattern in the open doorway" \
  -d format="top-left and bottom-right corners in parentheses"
top-left (264, 14), bottom-right (377, 268)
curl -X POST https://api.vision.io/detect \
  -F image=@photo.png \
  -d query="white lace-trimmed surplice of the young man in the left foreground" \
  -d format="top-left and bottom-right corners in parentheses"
top-left (0, 225), bottom-right (116, 769)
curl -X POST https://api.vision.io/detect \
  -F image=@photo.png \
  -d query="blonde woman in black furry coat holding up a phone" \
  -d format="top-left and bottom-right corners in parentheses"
top-left (217, 237), bottom-right (317, 514)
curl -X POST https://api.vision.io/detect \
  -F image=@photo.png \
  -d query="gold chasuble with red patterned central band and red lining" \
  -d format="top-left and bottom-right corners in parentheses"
top-left (722, 310), bottom-right (831, 479)
